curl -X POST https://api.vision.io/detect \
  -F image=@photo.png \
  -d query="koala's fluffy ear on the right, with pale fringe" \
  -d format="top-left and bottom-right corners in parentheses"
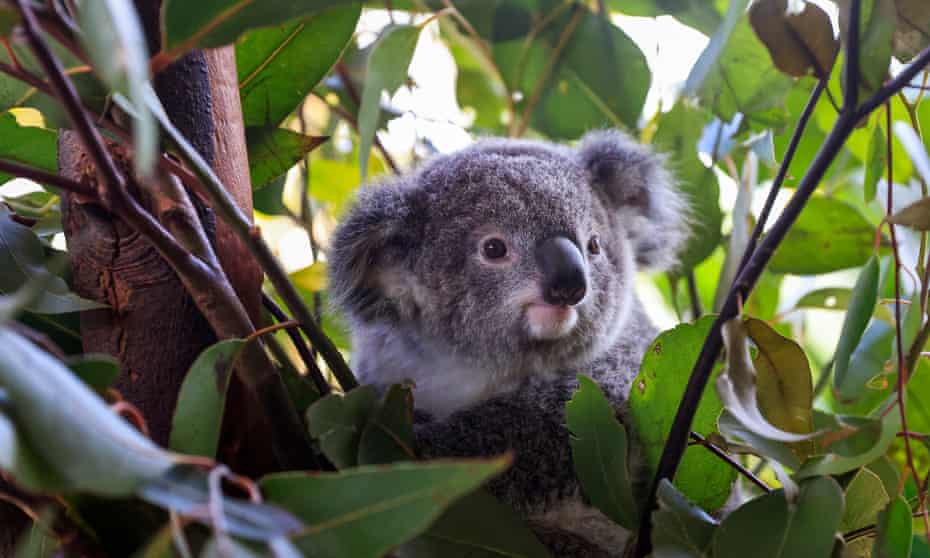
top-left (578, 130), bottom-right (688, 271)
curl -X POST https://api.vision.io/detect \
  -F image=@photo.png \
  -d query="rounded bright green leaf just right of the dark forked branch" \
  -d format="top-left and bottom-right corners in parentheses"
top-left (769, 197), bottom-right (875, 275)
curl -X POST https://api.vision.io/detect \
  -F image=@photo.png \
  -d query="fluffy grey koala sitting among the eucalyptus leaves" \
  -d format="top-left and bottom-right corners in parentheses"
top-left (328, 131), bottom-right (688, 556)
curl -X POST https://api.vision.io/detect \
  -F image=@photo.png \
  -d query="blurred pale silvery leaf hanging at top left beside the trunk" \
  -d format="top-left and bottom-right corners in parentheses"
top-left (78, 0), bottom-right (159, 177)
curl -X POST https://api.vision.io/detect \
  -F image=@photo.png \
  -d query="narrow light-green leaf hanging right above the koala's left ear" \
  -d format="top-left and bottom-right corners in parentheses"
top-left (358, 25), bottom-right (420, 180)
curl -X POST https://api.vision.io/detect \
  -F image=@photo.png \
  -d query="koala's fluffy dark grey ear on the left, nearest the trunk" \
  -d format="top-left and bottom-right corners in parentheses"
top-left (327, 181), bottom-right (419, 321)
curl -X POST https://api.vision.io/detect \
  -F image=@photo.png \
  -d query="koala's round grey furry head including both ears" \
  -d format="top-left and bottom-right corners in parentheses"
top-left (329, 132), bottom-right (686, 373)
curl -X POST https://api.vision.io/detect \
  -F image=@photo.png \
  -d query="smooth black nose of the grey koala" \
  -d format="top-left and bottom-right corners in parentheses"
top-left (536, 236), bottom-right (588, 306)
